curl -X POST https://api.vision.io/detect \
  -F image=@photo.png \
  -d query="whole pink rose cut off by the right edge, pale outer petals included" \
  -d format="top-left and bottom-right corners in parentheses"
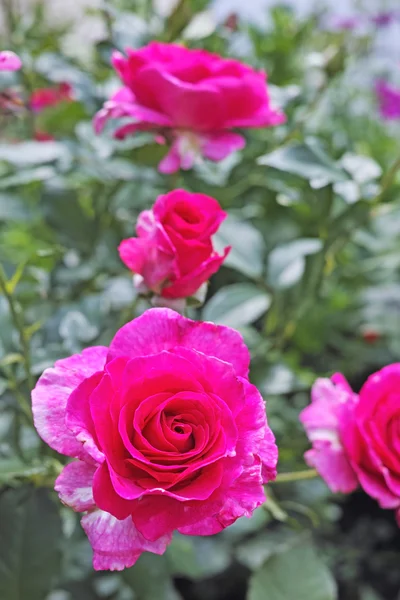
top-left (300, 363), bottom-right (400, 524)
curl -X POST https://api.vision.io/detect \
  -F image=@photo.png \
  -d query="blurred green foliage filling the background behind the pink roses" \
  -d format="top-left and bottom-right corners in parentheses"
top-left (0, 0), bottom-right (400, 600)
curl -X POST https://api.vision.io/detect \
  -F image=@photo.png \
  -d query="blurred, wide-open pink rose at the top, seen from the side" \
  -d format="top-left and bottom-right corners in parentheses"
top-left (95, 42), bottom-right (285, 173)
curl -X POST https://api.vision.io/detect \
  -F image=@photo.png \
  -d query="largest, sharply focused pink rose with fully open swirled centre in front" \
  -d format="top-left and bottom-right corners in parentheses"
top-left (32, 308), bottom-right (277, 570)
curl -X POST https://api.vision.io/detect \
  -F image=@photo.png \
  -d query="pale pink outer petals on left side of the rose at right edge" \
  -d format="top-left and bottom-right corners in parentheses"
top-left (299, 373), bottom-right (358, 493)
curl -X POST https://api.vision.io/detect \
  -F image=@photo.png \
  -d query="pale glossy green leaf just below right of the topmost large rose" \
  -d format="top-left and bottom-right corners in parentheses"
top-left (257, 140), bottom-right (348, 188)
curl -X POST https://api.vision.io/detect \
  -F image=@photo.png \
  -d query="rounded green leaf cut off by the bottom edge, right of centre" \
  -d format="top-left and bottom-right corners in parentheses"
top-left (247, 542), bottom-right (337, 600)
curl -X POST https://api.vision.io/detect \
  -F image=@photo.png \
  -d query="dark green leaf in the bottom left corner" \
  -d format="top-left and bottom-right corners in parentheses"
top-left (0, 487), bottom-right (62, 600)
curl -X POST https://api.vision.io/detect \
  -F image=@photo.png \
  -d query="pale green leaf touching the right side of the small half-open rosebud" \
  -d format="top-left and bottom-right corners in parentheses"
top-left (215, 215), bottom-right (265, 278)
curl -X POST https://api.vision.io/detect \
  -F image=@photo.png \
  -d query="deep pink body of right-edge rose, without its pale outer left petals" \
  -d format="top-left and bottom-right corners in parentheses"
top-left (342, 363), bottom-right (400, 523)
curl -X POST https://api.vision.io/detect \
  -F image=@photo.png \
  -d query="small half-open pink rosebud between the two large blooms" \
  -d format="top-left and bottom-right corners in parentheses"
top-left (119, 190), bottom-right (230, 299)
